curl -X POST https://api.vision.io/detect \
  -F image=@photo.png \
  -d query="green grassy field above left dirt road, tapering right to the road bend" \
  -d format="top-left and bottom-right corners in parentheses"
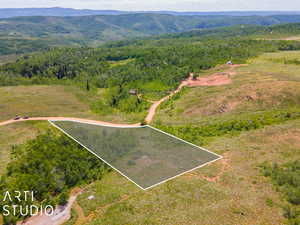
top-left (0, 85), bottom-right (144, 123)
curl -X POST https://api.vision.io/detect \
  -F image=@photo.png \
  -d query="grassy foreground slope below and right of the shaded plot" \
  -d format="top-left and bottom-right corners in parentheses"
top-left (71, 121), bottom-right (300, 225)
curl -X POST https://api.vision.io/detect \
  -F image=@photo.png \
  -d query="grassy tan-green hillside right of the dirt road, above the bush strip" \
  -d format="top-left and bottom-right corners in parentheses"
top-left (154, 51), bottom-right (300, 125)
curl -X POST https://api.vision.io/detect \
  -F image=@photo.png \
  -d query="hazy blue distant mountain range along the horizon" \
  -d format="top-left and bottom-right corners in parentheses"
top-left (0, 7), bottom-right (300, 18)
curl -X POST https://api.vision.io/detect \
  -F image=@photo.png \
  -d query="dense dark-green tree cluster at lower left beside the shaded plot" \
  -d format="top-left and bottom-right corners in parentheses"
top-left (0, 130), bottom-right (107, 224)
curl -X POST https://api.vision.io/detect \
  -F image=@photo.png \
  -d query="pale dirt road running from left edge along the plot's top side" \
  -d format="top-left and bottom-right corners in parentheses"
top-left (0, 117), bottom-right (140, 127)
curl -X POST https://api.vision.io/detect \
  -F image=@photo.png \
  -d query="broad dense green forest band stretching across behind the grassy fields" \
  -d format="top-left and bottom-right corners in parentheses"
top-left (0, 34), bottom-right (300, 112)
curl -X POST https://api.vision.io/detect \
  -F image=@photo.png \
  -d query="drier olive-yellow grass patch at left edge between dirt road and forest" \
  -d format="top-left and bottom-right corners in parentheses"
top-left (0, 86), bottom-right (89, 121)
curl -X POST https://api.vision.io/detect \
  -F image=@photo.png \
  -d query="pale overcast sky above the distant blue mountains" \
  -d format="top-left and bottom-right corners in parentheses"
top-left (0, 0), bottom-right (300, 11)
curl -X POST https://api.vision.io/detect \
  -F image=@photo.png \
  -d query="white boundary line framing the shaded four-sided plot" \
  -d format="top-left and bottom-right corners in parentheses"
top-left (48, 119), bottom-right (223, 191)
